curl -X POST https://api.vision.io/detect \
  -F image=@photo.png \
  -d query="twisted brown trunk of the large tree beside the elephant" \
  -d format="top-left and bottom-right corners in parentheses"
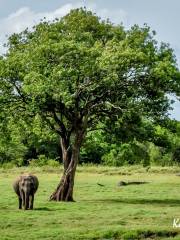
top-left (50, 130), bottom-right (83, 202)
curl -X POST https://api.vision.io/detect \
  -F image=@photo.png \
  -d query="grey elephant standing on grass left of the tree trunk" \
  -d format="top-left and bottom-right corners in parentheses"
top-left (13, 174), bottom-right (39, 210)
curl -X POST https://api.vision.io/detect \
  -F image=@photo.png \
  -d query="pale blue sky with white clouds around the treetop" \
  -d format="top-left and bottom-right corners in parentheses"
top-left (0, 0), bottom-right (180, 120)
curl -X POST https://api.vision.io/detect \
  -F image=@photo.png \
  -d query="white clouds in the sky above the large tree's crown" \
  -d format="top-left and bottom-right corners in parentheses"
top-left (0, 2), bottom-right (127, 53)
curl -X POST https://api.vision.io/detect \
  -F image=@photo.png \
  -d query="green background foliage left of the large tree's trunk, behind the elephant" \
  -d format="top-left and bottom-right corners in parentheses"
top-left (0, 109), bottom-right (59, 166)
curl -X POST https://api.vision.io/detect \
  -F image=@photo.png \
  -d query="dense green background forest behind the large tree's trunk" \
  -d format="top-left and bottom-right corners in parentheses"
top-left (0, 109), bottom-right (180, 167)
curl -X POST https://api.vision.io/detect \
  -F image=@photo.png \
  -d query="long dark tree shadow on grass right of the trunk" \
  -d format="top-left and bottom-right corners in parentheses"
top-left (90, 198), bottom-right (180, 206)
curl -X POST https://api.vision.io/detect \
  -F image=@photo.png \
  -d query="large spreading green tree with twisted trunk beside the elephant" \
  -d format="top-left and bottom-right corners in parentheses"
top-left (0, 9), bottom-right (179, 201)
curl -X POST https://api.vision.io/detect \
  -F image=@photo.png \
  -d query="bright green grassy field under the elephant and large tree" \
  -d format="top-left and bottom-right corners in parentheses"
top-left (0, 166), bottom-right (180, 240)
